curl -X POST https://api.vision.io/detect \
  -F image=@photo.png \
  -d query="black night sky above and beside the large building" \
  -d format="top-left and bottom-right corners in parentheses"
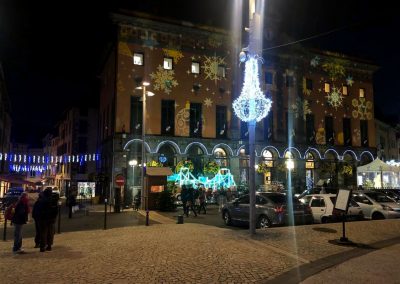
top-left (0, 0), bottom-right (400, 145)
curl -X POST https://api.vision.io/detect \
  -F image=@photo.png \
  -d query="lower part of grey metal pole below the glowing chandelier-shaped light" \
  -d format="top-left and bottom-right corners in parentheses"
top-left (248, 120), bottom-right (256, 235)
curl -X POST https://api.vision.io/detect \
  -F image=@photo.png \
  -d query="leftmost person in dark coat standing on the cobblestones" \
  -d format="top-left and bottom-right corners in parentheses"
top-left (11, 192), bottom-right (29, 254)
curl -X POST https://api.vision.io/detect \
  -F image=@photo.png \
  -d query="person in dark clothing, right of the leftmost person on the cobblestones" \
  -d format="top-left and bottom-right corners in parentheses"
top-left (38, 188), bottom-right (58, 252)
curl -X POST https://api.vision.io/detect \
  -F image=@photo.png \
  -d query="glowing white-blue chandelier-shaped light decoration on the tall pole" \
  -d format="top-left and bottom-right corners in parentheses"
top-left (233, 56), bottom-right (272, 122)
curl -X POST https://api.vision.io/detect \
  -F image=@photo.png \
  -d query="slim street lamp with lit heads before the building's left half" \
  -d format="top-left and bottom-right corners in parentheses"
top-left (136, 81), bottom-right (154, 226)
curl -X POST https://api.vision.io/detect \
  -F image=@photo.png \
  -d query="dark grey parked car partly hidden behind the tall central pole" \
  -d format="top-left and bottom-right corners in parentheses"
top-left (221, 192), bottom-right (313, 228)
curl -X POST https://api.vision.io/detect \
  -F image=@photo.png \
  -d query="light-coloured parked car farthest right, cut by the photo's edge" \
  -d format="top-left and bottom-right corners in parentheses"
top-left (352, 191), bottom-right (400, 220)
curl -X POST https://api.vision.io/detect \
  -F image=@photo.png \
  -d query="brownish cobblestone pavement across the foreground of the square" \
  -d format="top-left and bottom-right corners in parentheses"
top-left (0, 206), bottom-right (400, 283)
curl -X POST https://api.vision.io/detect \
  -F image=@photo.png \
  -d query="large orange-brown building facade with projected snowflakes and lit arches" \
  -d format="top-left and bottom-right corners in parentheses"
top-left (99, 11), bottom-right (376, 202)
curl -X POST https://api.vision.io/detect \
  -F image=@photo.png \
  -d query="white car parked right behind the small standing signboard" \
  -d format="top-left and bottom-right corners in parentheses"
top-left (300, 193), bottom-right (364, 223)
